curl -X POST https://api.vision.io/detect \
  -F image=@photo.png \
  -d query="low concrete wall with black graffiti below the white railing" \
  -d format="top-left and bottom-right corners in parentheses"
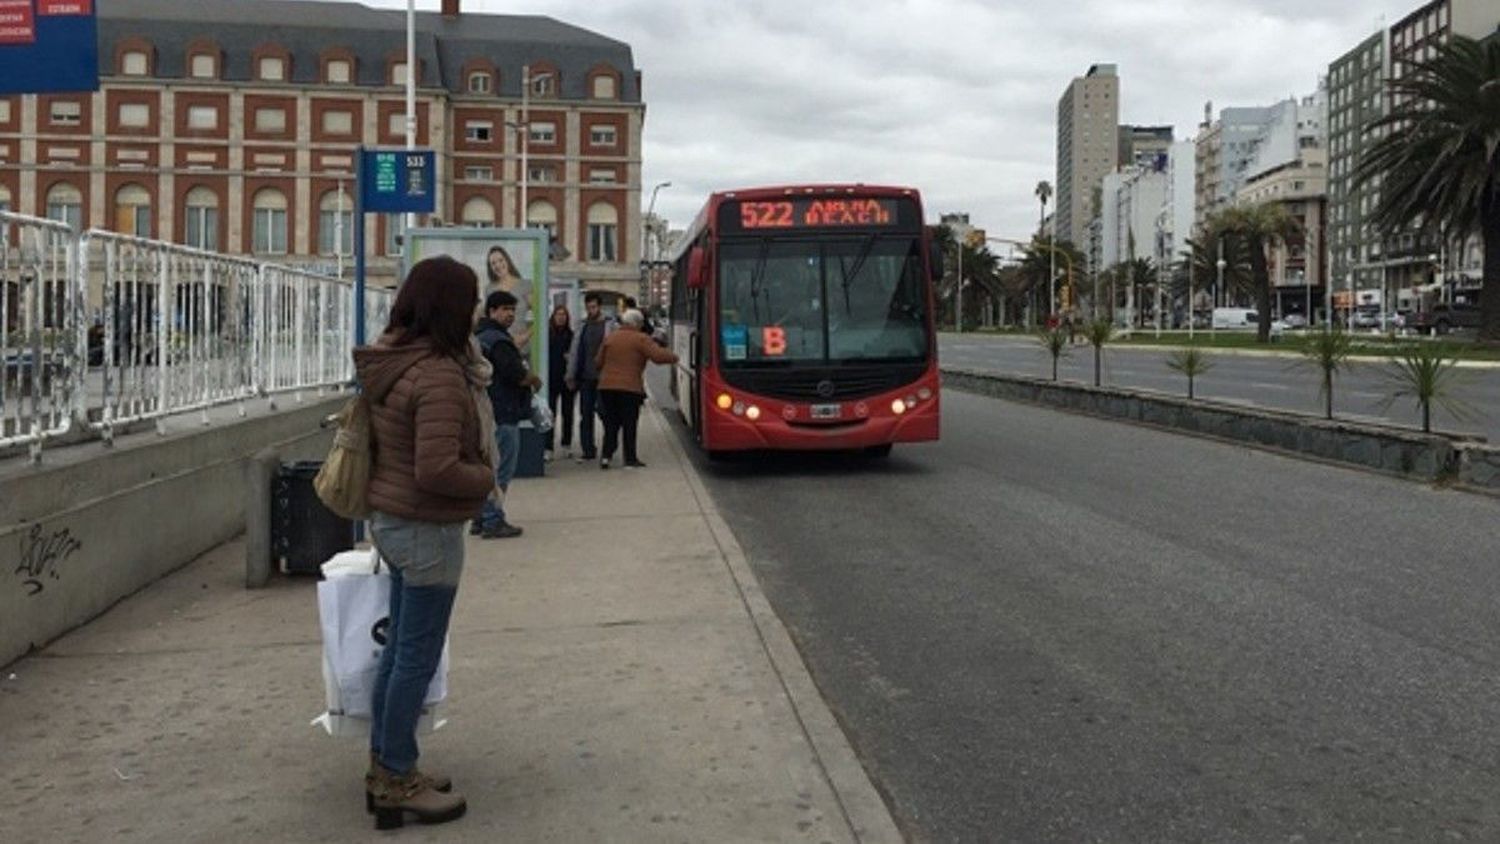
top-left (0, 396), bottom-right (345, 666)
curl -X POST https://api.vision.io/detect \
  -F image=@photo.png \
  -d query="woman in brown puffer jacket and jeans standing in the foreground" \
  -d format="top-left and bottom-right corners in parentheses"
top-left (354, 258), bottom-right (495, 829)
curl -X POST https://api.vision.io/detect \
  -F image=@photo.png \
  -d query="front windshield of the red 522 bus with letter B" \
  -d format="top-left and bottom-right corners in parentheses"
top-left (719, 234), bottom-right (929, 366)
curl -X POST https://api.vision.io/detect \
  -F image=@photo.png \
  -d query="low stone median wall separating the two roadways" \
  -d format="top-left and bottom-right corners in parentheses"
top-left (944, 369), bottom-right (1500, 493)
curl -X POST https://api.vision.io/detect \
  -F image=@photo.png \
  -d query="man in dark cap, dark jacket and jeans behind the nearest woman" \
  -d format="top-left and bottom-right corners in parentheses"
top-left (473, 291), bottom-right (542, 540)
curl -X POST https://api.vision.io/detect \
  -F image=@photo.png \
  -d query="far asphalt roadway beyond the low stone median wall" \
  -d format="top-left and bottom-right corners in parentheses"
top-left (939, 334), bottom-right (1500, 442)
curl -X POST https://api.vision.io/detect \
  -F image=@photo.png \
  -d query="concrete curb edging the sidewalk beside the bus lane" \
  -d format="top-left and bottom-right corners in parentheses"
top-left (648, 406), bottom-right (905, 843)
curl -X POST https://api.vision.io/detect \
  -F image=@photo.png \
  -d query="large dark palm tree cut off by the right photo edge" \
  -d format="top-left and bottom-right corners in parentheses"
top-left (1355, 36), bottom-right (1500, 342)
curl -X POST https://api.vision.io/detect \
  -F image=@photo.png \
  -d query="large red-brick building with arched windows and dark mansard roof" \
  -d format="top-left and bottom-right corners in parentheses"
top-left (0, 0), bottom-right (645, 294)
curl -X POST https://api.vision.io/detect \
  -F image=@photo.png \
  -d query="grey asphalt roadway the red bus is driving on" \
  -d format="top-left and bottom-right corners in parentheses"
top-left (656, 372), bottom-right (1500, 841)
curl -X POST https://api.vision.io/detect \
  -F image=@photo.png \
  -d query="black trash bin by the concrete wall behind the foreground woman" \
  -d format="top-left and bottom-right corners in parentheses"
top-left (272, 460), bottom-right (354, 574)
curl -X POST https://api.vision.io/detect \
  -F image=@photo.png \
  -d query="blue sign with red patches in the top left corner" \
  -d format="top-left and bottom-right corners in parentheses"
top-left (0, 0), bottom-right (99, 94)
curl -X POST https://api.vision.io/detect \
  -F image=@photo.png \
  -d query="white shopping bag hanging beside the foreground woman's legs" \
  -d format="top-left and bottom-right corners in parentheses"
top-left (314, 550), bottom-right (449, 736)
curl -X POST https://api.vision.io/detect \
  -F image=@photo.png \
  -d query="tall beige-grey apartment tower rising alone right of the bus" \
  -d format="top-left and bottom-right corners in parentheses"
top-left (1056, 64), bottom-right (1121, 244)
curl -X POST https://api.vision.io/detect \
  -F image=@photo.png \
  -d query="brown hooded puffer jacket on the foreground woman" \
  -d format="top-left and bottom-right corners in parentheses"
top-left (354, 337), bottom-right (495, 523)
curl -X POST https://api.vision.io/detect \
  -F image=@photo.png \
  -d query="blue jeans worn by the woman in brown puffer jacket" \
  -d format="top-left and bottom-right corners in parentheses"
top-left (371, 513), bottom-right (464, 774)
